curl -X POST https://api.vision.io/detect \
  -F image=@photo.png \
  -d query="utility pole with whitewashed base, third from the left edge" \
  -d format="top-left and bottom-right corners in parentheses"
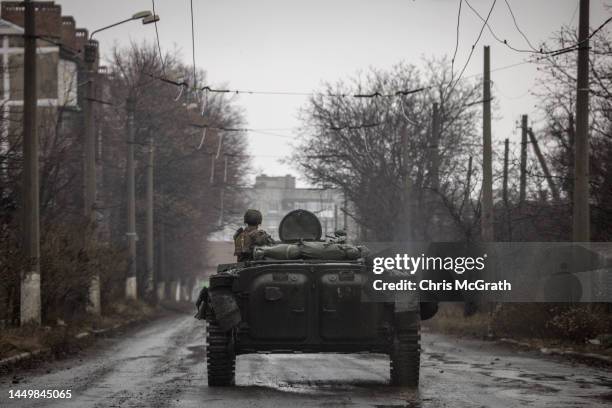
top-left (125, 96), bottom-right (138, 299)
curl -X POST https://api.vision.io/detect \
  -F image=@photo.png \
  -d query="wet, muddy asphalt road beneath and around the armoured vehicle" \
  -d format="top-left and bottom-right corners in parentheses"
top-left (0, 315), bottom-right (612, 408)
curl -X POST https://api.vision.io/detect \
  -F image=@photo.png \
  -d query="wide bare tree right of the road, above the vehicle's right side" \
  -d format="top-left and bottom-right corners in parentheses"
top-left (293, 61), bottom-right (481, 240)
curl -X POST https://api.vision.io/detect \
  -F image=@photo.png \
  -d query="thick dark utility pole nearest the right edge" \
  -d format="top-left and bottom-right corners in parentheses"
top-left (573, 0), bottom-right (591, 242)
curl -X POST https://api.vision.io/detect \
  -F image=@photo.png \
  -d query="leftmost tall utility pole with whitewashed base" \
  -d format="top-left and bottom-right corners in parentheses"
top-left (20, 0), bottom-right (41, 325)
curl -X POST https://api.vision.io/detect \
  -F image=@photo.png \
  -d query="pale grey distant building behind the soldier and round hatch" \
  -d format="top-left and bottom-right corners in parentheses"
top-left (210, 175), bottom-right (357, 241)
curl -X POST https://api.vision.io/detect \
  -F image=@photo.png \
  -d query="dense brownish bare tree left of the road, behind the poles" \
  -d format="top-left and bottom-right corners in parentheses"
top-left (102, 44), bottom-right (249, 296)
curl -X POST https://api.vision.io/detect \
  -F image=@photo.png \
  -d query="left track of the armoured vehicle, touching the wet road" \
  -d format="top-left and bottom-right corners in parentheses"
top-left (206, 322), bottom-right (236, 387)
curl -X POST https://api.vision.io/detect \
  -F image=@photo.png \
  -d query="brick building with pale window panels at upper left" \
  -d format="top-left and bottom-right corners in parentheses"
top-left (0, 1), bottom-right (107, 217)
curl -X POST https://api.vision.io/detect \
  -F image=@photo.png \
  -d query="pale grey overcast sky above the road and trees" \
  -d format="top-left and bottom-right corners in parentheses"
top-left (56, 0), bottom-right (610, 186)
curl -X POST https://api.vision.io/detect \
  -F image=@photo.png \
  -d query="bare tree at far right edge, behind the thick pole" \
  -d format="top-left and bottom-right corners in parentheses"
top-left (532, 27), bottom-right (612, 241)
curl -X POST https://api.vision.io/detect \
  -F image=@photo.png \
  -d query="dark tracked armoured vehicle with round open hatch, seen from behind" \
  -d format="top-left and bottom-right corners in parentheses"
top-left (199, 210), bottom-right (420, 386)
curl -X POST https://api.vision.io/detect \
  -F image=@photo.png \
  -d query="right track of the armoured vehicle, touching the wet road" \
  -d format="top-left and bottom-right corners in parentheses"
top-left (390, 313), bottom-right (421, 387)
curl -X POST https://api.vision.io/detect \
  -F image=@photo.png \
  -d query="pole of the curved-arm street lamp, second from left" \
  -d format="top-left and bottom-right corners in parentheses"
top-left (83, 40), bottom-right (101, 315)
